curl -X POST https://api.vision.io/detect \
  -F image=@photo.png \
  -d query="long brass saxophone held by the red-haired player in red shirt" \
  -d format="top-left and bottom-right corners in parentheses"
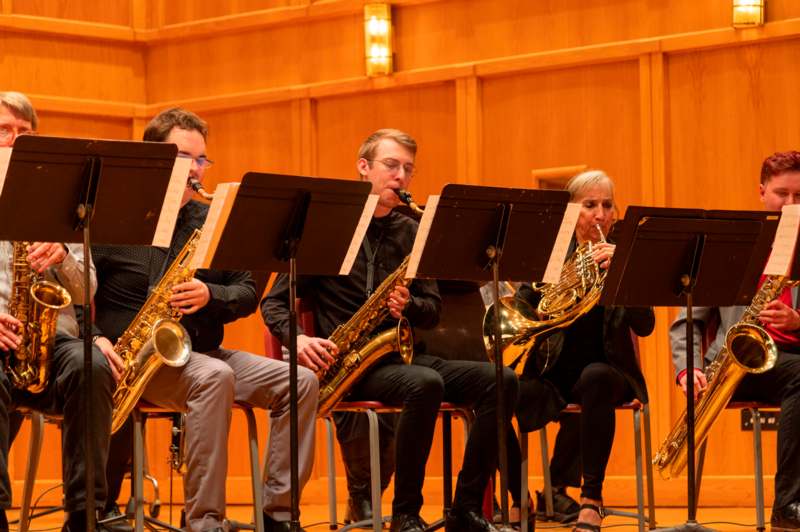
top-left (653, 275), bottom-right (796, 479)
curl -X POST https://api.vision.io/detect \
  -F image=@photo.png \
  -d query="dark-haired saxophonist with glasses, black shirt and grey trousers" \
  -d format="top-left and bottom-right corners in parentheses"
top-left (92, 109), bottom-right (318, 531)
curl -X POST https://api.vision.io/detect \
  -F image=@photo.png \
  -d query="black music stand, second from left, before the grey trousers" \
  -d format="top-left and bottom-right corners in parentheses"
top-left (200, 172), bottom-right (372, 531)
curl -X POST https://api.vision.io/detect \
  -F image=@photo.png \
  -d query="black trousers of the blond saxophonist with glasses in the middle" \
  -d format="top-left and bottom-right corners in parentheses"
top-left (349, 355), bottom-right (517, 515)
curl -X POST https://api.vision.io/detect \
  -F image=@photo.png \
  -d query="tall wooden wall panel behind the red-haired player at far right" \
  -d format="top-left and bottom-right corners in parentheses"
top-left (667, 39), bottom-right (800, 209)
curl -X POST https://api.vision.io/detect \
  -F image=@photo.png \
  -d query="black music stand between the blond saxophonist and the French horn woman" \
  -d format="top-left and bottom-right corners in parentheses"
top-left (409, 185), bottom-right (569, 530)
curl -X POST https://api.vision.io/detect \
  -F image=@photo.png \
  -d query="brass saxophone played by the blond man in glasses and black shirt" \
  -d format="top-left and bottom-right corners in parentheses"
top-left (317, 190), bottom-right (422, 417)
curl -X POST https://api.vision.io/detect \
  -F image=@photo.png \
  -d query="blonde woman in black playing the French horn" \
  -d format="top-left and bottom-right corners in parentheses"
top-left (509, 170), bottom-right (655, 531)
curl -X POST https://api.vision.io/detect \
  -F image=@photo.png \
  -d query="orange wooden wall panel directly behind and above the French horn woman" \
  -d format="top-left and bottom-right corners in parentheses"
top-left (483, 62), bottom-right (641, 210)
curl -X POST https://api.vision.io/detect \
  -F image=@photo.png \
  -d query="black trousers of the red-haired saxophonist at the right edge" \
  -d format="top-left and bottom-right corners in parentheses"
top-left (734, 351), bottom-right (800, 509)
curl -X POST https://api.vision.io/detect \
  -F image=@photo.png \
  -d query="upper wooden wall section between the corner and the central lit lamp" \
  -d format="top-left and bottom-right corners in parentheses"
top-left (147, 15), bottom-right (364, 102)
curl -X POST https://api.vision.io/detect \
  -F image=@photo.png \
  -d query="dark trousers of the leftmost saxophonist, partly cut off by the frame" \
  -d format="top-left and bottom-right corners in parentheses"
top-left (0, 335), bottom-right (115, 512)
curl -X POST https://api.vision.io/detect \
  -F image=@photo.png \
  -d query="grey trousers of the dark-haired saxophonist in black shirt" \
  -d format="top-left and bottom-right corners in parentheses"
top-left (144, 349), bottom-right (319, 531)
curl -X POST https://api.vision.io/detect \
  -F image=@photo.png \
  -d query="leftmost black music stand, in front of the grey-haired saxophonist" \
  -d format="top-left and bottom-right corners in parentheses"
top-left (0, 135), bottom-right (179, 532)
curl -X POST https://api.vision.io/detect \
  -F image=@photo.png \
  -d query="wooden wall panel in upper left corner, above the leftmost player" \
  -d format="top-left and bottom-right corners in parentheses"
top-left (0, 32), bottom-right (145, 103)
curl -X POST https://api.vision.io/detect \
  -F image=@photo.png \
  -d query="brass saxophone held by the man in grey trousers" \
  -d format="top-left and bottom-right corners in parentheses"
top-left (111, 229), bottom-right (200, 434)
